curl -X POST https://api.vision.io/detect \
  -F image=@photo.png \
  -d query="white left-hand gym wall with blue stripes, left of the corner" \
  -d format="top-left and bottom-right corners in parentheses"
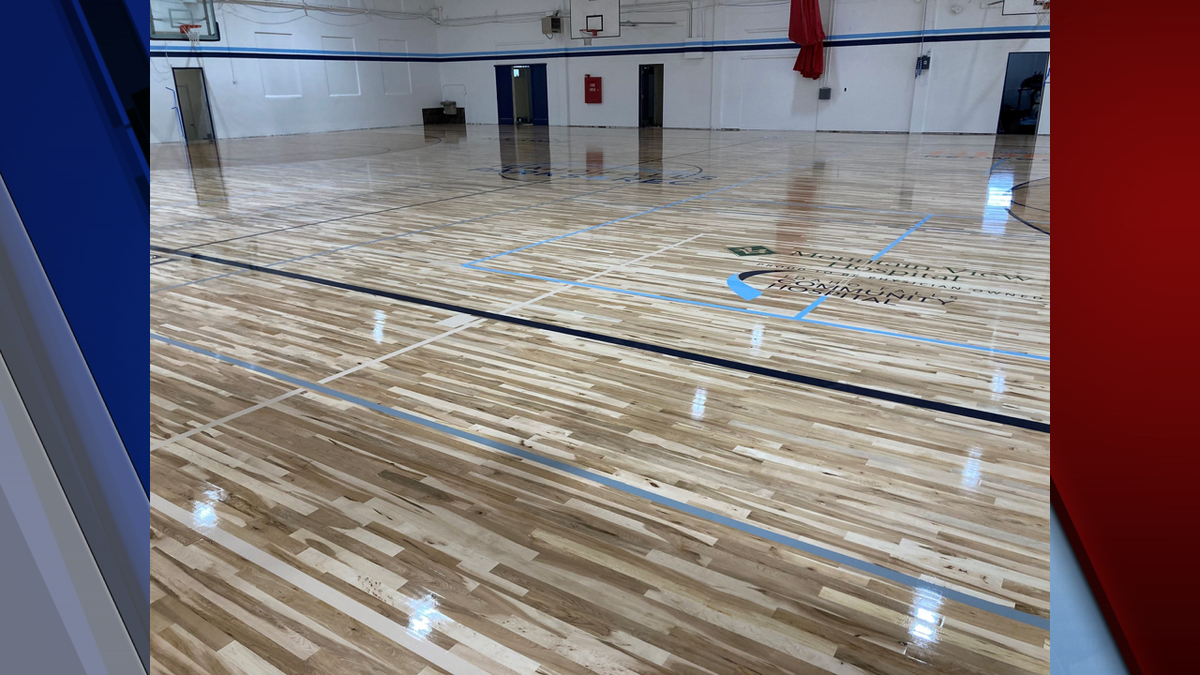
top-left (150, 0), bottom-right (442, 143)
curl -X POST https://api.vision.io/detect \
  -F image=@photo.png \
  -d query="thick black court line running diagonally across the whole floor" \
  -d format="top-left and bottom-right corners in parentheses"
top-left (150, 245), bottom-right (1050, 434)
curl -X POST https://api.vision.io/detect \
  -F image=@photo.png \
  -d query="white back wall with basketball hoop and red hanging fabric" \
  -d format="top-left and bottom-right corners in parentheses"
top-left (437, 0), bottom-right (1050, 133)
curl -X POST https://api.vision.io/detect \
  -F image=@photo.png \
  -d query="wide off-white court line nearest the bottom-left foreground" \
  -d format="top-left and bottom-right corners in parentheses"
top-left (150, 492), bottom-right (488, 675)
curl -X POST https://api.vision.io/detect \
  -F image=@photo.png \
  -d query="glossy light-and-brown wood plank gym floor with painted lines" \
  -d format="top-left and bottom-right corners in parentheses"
top-left (150, 126), bottom-right (1050, 675)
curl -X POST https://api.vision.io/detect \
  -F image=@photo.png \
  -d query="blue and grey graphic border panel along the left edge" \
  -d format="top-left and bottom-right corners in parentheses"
top-left (0, 0), bottom-right (150, 673)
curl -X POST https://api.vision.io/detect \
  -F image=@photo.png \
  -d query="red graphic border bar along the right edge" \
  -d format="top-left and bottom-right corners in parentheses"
top-left (1051, 0), bottom-right (1200, 675)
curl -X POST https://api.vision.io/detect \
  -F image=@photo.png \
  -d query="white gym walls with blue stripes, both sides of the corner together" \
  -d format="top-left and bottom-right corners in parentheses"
top-left (151, 0), bottom-right (1050, 142)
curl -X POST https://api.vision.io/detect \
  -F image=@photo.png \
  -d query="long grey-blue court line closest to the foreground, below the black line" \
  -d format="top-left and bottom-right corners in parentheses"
top-left (150, 331), bottom-right (1050, 631)
